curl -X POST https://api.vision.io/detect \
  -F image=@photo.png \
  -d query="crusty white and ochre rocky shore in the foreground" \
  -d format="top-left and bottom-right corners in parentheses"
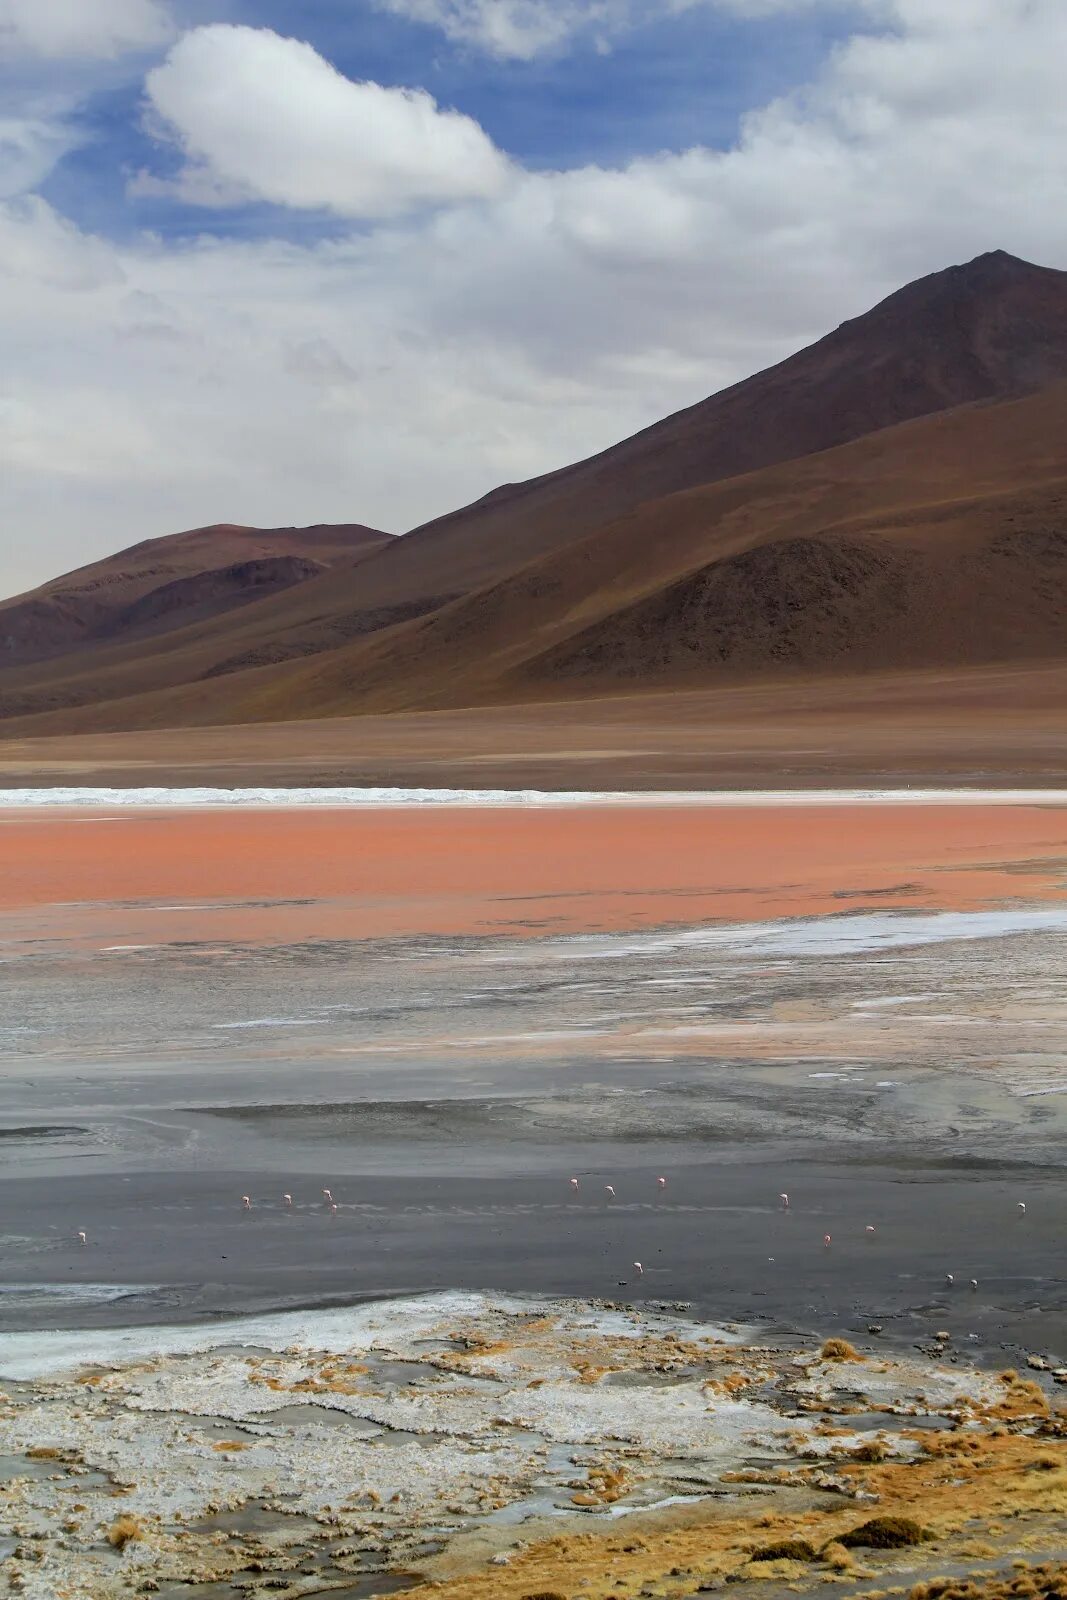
top-left (0, 1296), bottom-right (1067, 1600)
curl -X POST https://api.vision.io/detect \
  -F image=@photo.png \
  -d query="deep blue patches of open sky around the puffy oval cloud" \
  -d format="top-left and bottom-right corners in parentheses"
top-left (31, 0), bottom-right (848, 238)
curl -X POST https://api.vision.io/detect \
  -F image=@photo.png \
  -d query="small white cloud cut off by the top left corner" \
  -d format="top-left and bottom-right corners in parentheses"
top-left (0, 0), bottom-right (174, 59)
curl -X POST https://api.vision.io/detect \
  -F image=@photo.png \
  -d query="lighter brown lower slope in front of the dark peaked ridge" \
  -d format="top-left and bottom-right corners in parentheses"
top-left (8, 386), bottom-right (1067, 734)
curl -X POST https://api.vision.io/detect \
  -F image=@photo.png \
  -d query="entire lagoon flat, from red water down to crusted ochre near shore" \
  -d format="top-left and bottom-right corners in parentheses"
top-left (0, 795), bottom-right (1067, 1600)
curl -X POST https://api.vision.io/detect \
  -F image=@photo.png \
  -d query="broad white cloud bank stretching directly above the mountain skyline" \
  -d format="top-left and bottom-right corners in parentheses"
top-left (0, 0), bottom-right (1067, 590)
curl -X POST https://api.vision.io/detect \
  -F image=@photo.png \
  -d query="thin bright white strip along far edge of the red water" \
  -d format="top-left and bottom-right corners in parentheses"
top-left (0, 786), bottom-right (1067, 811)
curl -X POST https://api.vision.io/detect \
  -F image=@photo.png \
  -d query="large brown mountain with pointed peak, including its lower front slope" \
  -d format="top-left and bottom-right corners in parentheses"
top-left (0, 251), bottom-right (1067, 731)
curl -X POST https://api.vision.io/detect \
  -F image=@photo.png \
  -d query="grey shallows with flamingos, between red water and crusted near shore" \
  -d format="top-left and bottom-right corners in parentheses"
top-left (0, 906), bottom-right (1067, 1355)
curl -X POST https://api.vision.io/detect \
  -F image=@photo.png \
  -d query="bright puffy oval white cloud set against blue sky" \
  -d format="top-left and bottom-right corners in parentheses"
top-left (134, 24), bottom-right (509, 218)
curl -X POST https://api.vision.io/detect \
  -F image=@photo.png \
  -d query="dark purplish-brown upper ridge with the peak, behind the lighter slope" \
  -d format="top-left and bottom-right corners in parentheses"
top-left (337, 251), bottom-right (1067, 595)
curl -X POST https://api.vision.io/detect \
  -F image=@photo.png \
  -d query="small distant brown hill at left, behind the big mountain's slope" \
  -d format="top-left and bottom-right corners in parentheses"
top-left (0, 523), bottom-right (390, 669)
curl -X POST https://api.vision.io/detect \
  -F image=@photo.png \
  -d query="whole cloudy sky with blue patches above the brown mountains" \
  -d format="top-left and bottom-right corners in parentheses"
top-left (0, 0), bottom-right (1067, 594)
